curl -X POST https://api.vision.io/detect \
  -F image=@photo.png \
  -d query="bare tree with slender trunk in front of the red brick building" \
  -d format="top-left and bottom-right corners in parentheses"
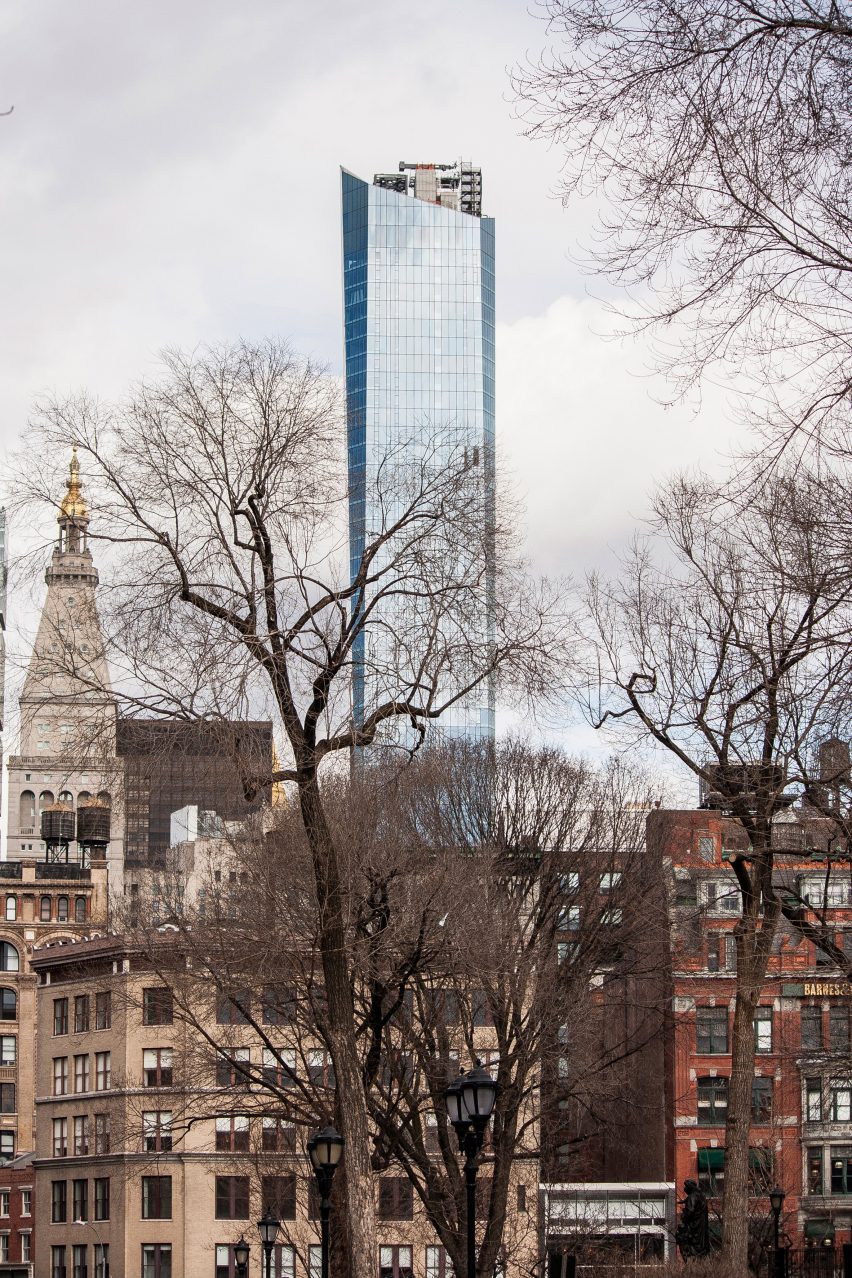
top-left (579, 465), bottom-right (852, 1265)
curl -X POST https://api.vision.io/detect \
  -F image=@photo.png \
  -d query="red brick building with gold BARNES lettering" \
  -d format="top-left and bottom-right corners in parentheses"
top-left (648, 809), bottom-right (852, 1249)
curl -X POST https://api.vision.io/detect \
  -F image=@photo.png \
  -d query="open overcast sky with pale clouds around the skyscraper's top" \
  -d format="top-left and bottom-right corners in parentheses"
top-left (0, 0), bottom-right (731, 782)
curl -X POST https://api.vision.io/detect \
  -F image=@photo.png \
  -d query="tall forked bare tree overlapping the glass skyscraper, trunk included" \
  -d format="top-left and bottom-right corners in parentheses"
top-left (15, 341), bottom-right (563, 1278)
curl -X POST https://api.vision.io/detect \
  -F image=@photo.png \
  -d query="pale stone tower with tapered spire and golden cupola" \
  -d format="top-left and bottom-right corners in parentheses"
top-left (6, 449), bottom-right (123, 883)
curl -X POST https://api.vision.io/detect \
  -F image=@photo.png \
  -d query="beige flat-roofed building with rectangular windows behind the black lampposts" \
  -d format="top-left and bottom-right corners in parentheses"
top-left (33, 933), bottom-right (539, 1278)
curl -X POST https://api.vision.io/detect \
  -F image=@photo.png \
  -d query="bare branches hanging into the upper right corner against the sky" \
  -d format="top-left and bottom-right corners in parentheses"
top-left (515, 0), bottom-right (852, 447)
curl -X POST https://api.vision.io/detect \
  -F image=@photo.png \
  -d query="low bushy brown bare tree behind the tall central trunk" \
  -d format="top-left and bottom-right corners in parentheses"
top-left (118, 743), bottom-right (667, 1278)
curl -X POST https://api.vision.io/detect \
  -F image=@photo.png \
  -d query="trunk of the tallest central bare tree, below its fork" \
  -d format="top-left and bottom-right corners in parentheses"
top-left (299, 774), bottom-right (378, 1278)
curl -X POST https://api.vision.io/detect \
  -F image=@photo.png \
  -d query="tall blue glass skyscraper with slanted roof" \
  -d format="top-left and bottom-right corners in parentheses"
top-left (342, 162), bottom-right (494, 740)
